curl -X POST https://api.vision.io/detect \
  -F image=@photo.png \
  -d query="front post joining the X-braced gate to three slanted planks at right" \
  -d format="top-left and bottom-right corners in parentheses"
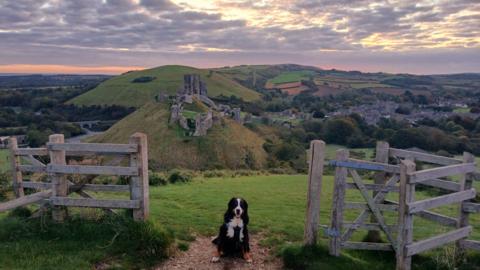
top-left (396, 160), bottom-right (415, 270)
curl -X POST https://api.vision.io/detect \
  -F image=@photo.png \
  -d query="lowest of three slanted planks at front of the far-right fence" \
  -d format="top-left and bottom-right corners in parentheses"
top-left (405, 226), bottom-right (472, 256)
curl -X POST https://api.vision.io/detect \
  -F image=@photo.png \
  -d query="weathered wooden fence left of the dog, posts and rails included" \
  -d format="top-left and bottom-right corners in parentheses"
top-left (0, 133), bottom-right (149, 222)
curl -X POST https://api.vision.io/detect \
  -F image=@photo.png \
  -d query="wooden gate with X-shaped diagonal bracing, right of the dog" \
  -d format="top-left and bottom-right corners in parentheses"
top-left (329, 149), bottom-right (400, 256)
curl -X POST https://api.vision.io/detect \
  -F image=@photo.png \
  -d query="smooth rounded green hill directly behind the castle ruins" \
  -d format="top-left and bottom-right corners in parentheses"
top-left (69, 65), bottom-right (260, 107)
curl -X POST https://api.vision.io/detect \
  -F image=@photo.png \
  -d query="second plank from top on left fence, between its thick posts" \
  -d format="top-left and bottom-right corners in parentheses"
top-left (47, 165), bottom-right (138, 176)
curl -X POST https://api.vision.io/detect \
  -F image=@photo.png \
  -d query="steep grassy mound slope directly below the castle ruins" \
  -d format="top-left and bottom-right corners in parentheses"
top-left (92, 103), bottom-right (267, 169)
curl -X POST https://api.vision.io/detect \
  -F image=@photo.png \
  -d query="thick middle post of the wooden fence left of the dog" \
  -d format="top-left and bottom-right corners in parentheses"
top-left (48, 134), bottom-right (68, 222)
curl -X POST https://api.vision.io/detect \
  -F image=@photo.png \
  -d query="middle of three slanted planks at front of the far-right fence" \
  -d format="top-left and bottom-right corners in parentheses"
top-left (407, 188), bottom-right (476, 214)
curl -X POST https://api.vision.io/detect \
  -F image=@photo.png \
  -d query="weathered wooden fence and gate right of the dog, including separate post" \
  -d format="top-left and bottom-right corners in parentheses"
top-left (304, 141), bottom-right (480, 270)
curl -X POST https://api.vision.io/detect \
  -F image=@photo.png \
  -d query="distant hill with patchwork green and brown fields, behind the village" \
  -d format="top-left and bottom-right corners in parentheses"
top-left (216, 64), bottom-right (480, 96)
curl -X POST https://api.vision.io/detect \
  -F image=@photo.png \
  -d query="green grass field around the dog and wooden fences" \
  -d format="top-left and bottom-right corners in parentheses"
top-left (0, 175), bottom-right (480, 270)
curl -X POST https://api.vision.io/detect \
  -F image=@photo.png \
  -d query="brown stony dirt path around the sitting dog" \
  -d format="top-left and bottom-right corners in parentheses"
top-left (156, 235), bottom-right (282, 270)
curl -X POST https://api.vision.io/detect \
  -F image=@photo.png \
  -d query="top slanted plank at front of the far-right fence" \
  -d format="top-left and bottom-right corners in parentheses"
top-left (410, 163), bottom-right (476, 184)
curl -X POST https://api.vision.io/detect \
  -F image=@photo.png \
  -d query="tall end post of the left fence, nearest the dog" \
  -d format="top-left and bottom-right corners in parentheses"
top-left (129, 132), bottom-right (150, 220)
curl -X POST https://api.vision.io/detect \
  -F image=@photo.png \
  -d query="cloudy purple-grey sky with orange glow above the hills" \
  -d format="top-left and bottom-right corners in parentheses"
top-left (0, 0), bottom-right (480, 74)
